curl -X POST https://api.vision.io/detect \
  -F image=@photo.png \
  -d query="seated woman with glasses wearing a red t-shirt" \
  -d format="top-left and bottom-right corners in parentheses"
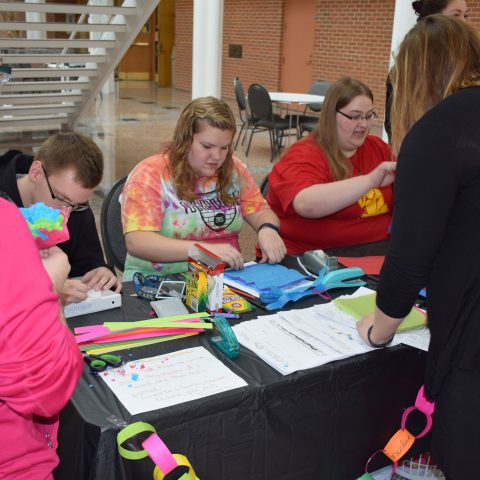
top-left (267, 77), bottom-right (395, 254)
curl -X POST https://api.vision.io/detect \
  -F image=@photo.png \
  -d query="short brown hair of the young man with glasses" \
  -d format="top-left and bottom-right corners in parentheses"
top-left (35, 132), bottom-right (103, 189)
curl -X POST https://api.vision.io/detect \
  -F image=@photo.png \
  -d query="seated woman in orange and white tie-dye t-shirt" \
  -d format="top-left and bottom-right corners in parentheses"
top-left (122, 97), bottom-right (285, 280)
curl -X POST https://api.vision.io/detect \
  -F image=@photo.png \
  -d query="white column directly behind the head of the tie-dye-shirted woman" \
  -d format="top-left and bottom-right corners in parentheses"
top-left (192, 0), bottom-right (223, 99)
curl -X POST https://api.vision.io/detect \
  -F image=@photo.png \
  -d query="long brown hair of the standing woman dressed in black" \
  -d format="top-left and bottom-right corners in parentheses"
top-left (391, 15), bottom-right (480, 153)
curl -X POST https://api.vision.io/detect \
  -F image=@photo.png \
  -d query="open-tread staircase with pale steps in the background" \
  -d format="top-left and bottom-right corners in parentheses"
top-left (0, 0), bottom-right (160, 132)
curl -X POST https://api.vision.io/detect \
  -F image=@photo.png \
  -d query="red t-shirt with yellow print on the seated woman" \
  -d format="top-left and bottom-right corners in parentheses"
top-left (267, 135), bottom-right (393, 254)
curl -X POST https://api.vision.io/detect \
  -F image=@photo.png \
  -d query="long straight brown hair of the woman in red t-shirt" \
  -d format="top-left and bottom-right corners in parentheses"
top-left (313, 77), bottom-right (373, 180)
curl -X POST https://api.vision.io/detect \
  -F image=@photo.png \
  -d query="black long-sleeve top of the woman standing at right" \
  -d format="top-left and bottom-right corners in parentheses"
top-left (377, 87), bottom-right (480, 398)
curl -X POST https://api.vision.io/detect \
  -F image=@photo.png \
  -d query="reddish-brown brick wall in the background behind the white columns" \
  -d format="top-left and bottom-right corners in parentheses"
top-left (175, 0), bottom-right (480, 126)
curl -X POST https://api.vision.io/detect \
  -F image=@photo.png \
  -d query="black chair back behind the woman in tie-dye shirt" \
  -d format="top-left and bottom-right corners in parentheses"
top-left (100, 177), bottom-right (127, 272)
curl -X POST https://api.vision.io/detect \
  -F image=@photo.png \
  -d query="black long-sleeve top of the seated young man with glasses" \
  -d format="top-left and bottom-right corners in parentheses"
top-left (0, 150), bottom-right (110, 277)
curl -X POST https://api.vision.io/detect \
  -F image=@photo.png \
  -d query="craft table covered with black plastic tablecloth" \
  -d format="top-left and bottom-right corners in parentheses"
top-left (55, 246), bottom-right (429, 480)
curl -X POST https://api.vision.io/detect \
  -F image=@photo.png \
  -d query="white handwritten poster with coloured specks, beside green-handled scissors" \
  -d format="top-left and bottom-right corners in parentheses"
top-left (100, 347), bottom-right (251, 415)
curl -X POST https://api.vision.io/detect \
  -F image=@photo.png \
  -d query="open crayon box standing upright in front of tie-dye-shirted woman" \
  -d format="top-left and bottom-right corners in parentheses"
top-left (185, 243), bottom-right (225, 312)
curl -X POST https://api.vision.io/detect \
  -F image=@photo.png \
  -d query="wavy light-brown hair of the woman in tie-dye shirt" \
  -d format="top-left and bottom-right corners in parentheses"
top-left (166, 97), bottom-right (236, 204)
